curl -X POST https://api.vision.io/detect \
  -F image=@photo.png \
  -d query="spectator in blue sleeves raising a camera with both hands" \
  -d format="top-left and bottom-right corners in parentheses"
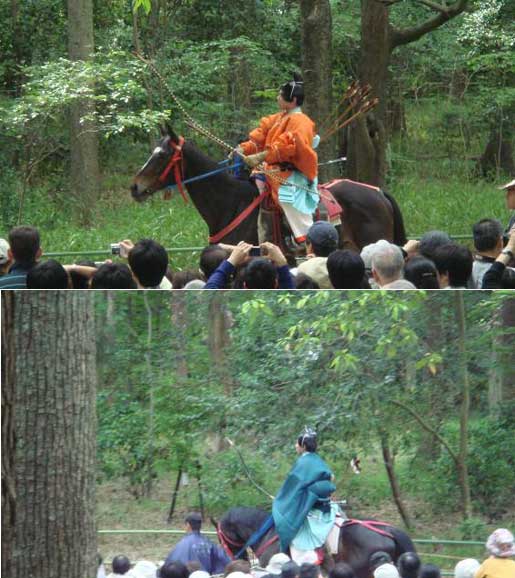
top-left (204, 241), bottom-right (295, 289)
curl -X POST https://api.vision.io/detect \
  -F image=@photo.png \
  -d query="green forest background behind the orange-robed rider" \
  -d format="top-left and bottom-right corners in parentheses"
top-left (0, 0), bottom-right (515, 268)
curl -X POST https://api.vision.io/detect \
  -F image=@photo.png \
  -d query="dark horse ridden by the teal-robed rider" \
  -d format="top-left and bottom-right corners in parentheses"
top-left (220, 508), bottom-right (415, 578)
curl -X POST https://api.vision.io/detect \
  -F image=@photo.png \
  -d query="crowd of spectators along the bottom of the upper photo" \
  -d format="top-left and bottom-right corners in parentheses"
top-left (0, 180), bottom-right (515, 289)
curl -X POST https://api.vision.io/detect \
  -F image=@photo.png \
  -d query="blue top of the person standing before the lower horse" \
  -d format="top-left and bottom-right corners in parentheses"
top-left (165, 532), bottom-right (231, 574)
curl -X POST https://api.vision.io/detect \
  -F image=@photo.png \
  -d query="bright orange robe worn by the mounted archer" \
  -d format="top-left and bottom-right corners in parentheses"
top-left (240, 109), bottom-right (318, 202)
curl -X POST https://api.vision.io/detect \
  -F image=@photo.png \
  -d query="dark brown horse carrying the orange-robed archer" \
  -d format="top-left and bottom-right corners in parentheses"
top-left (131, 128), bottom-right (406, 250)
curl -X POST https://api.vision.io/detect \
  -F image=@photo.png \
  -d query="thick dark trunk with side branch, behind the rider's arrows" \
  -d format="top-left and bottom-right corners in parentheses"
top-left (347, 0), bottom-right (392, 186)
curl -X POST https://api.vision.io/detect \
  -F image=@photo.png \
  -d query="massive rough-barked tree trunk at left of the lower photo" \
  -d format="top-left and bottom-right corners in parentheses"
top-left (8, 291), bottom-right (97, 578)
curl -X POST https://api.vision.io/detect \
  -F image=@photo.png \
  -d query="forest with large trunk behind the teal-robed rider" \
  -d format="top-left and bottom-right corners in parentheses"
top-left (2, 291), bottom-right (515, 576)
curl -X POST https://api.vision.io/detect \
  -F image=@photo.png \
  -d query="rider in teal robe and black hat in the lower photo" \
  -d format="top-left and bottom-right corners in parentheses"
top-left (272, 428), bottom-right (336, 552)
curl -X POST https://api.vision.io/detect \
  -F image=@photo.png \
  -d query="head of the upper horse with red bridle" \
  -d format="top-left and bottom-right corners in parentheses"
top-left (131, 126), bottom-right (183, 203)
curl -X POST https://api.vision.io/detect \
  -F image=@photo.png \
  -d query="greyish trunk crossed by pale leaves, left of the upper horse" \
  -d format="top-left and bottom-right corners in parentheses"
top-left (68, 0), bottom-right (100, 226)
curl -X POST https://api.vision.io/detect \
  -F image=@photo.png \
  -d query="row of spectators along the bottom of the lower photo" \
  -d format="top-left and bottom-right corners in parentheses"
top-left (97, 513), bottom-right (515, 578)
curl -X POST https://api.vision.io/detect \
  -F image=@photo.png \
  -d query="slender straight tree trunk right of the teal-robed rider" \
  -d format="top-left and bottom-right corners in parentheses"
top-left (454, 291), bottom-right (471, 519)
